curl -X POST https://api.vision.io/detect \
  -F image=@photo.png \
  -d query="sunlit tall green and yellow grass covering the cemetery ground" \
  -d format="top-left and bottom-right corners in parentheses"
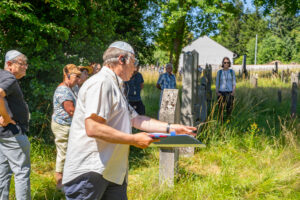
top-left (11, 72), bottom-right (300, 200)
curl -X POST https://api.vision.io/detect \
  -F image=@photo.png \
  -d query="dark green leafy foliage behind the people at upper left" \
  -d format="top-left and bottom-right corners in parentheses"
top-left (0, 0), bottom-right (153, 137)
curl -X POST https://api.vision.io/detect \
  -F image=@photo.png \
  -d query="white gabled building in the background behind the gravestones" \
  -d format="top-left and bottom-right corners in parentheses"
top-left (179, 36), bottom-right (235, 68)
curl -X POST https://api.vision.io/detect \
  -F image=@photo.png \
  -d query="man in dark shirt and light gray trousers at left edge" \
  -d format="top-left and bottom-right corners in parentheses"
top-left (0, 50), bottom-right (31, 200)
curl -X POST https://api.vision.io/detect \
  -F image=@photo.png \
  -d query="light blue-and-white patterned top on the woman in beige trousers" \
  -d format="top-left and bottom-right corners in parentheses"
top-left (52, 85), bottom-right (76, 125)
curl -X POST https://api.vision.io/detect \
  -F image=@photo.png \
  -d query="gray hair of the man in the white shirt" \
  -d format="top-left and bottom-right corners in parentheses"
top-left (103, 47), bottom-right (132, 66)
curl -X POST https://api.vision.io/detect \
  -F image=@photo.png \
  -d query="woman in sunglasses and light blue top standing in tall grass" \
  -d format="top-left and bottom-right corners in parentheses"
top-left (216, 57), bottom-right (236, 121)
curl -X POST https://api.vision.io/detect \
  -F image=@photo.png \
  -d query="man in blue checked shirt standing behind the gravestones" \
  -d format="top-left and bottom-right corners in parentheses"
top-left (156, 63), bottom-right (176, 117)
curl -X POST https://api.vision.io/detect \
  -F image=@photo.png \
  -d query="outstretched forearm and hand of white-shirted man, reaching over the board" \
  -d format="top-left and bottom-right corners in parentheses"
top-left (132, 115), bottom-right (197, 135)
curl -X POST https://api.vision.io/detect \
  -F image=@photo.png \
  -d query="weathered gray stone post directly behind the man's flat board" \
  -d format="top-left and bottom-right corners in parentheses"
top-left (159, 89), bottom-right (180, 187)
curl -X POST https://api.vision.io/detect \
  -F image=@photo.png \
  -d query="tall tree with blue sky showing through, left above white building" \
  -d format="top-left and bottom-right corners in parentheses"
top-left (155, 0), bottom-right (235, 73)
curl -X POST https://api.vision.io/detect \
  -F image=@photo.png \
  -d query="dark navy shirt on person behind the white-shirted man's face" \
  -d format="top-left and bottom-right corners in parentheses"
top-left (125, 72), bottom-right (144, 101)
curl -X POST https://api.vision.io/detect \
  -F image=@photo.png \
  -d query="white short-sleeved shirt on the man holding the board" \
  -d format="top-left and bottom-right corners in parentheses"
top-left (63, 66), bottom-right (138, 185)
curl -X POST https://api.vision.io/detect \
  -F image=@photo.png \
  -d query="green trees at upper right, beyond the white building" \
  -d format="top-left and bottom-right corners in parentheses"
top-left (215, 2), bottom-right (300, 64)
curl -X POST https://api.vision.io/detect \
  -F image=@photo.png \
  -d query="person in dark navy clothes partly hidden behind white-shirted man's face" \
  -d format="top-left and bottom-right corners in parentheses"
top-left (125, 66), bottom-right (145, 115)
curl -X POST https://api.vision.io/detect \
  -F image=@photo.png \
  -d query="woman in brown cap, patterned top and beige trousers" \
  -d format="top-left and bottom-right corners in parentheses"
top-left (51, 64), bottom-right (81, 189)
